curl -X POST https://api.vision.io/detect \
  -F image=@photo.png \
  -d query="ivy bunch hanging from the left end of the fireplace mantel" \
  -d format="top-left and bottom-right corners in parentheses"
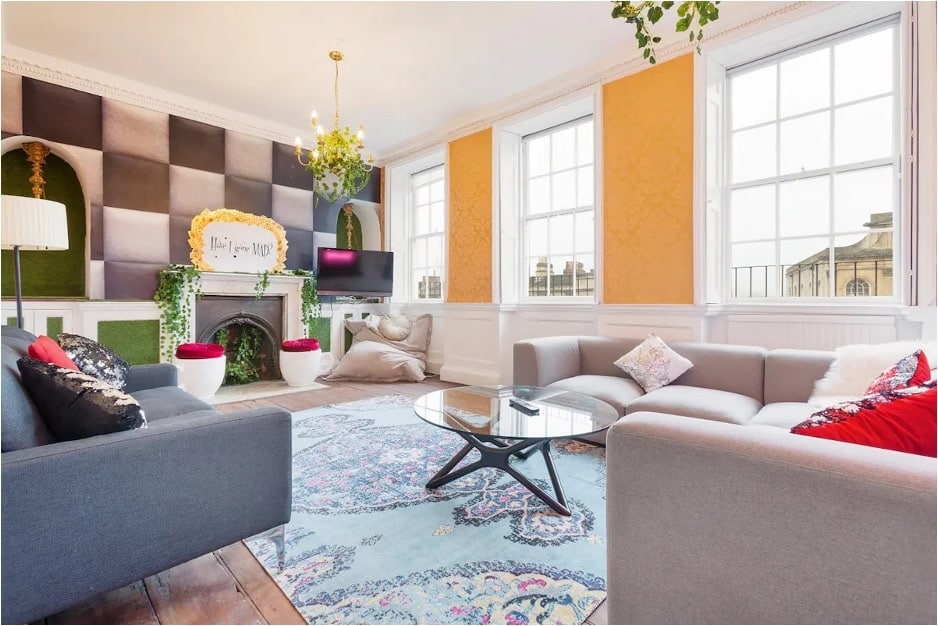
top-left (153, 264), bottom-right (202, 361)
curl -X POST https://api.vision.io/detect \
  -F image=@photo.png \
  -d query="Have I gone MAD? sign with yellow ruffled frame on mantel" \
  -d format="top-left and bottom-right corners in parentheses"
top-left (189, 209), bottom-right (287, 273)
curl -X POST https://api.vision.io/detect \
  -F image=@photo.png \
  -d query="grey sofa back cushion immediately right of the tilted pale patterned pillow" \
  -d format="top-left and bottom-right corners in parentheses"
top-left (668, 343), bottom-right (767, 400)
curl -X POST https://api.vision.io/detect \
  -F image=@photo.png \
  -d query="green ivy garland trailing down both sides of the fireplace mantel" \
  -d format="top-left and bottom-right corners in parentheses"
top-left (153, 264), bottom-right (322, 361)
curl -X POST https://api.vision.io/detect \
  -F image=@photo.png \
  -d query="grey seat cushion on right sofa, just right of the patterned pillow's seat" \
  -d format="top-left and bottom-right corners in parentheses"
top-left (626, 385), bottom-right (762, 424)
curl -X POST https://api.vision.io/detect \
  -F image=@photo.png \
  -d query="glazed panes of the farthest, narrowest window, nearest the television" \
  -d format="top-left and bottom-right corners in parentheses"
top-left (408, 165), bottom-right (446, 300)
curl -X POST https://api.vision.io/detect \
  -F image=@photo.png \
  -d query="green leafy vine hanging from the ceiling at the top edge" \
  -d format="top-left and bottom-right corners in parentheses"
top-left (612, 0), bottom-right (720, 65)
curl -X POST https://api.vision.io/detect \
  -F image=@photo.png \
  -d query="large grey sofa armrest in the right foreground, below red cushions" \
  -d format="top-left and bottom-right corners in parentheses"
top-left (606, 413), bottom-right (936, 624)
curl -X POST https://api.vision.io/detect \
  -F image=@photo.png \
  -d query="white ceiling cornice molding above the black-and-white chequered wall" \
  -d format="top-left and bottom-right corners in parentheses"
top-left (2, 45), bottom-right (296, 145)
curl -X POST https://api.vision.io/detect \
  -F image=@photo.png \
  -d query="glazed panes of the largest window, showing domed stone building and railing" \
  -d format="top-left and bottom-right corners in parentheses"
top-left (726, 18), bottom-right (901, 300)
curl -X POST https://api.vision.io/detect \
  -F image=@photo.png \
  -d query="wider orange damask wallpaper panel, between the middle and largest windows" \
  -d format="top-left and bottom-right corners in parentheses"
top-left (603, 54), bottom-right (694, 304)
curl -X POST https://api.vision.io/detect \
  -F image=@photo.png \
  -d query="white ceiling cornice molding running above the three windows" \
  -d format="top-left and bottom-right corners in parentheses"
top-left (382, 0), bottom-right (828, 165)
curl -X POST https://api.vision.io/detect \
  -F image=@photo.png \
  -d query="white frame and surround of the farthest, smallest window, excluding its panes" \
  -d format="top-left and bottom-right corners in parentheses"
top-left (385, 147), bottom-right (449, 305)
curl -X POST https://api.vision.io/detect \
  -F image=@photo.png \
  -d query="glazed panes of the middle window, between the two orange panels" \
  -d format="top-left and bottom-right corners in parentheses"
top-left (521, 116), bottom-right (596, 298)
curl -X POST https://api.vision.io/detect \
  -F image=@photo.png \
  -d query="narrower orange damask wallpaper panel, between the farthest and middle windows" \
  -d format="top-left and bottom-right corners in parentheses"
top-left (446, 128), bottom-right (492, 302)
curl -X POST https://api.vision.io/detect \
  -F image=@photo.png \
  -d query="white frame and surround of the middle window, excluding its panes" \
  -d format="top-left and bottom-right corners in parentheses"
top-left (494, 92), bottom-right (602, 306)
